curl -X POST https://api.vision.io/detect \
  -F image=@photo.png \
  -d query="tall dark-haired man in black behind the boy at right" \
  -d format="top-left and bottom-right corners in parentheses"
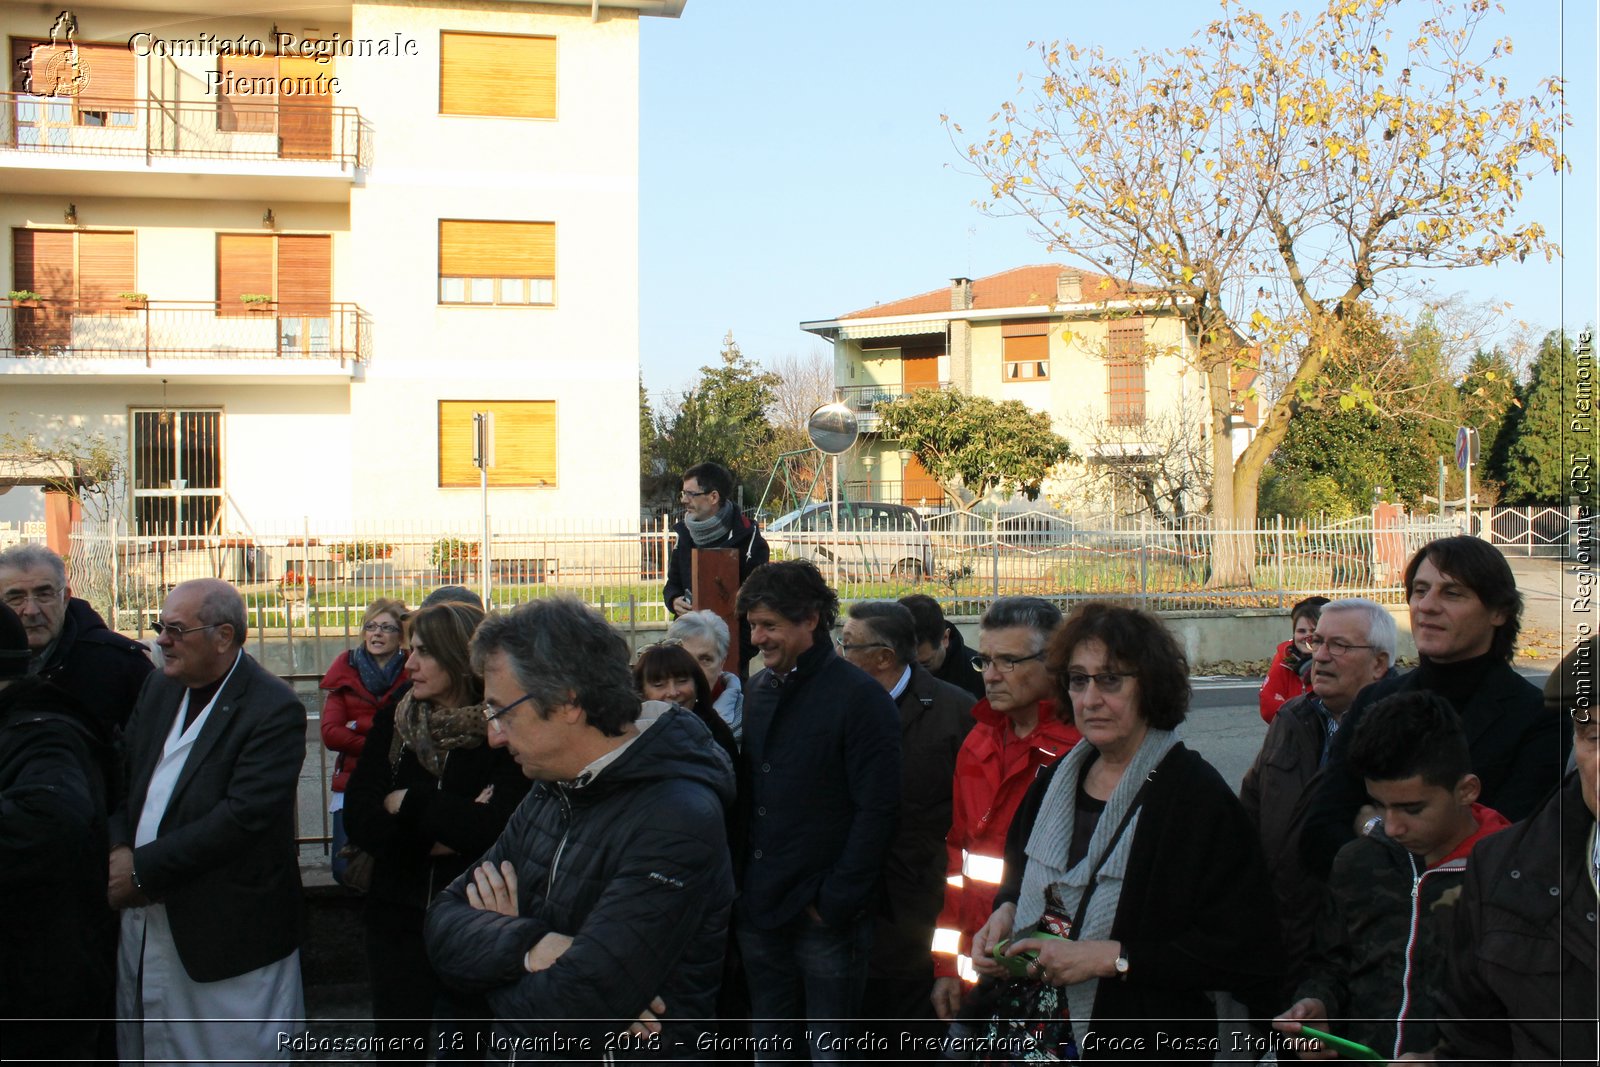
top-left (1301, 537), bottom-right (1571, 878)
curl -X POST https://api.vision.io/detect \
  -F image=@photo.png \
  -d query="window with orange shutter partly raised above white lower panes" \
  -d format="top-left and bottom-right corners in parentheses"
top-left (438, 219), bottom-right (555, 307)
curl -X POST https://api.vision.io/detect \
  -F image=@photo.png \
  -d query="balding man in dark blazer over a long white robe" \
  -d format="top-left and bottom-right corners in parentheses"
top-left (107, 579), bottom-right (306, 1061)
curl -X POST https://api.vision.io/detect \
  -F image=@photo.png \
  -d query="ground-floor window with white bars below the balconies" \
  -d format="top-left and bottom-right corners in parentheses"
top-left (130, 410), bottom-right (222, 537)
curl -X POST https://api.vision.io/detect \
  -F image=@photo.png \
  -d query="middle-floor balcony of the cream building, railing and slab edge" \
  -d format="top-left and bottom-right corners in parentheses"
top-left (0, 301), bottom-right (373, 382)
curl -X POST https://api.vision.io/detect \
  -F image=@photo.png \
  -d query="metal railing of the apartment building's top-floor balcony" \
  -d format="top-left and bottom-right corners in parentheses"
top-left (0, 93), bottom-right (365, 168)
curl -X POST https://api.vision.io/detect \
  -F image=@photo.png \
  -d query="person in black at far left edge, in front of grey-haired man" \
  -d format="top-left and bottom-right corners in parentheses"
top-left (0, 605), bottom-right (115, 1062)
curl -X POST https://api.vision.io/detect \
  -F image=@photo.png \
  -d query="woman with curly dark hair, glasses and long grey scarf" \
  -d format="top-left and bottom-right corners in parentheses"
top-left (973, 603), bottom-right (1283, 1062)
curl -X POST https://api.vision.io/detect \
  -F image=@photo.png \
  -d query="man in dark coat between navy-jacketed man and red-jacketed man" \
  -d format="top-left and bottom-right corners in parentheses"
top-left (838, 600), bottom-right (974, 1036)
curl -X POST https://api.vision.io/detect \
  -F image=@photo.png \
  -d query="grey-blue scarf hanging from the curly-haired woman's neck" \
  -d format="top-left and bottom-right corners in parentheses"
top-left (1013, 729), bottom-right (1178, 1048)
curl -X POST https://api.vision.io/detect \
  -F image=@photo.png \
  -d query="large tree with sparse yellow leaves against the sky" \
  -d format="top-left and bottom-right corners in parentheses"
top-left (950, 0), bottom-right (1571, 585)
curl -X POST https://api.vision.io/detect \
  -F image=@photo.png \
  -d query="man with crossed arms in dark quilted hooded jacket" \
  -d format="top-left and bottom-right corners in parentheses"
top-left (426, 597), bottom-right (734, 1061)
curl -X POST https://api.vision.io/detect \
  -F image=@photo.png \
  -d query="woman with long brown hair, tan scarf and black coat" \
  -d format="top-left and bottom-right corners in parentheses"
top-left (346, 603), bottom-right (528, 1059)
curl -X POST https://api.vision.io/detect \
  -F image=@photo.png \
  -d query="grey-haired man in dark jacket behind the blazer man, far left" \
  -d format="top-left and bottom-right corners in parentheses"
top-left (0, 544), bottom-right (154, 729)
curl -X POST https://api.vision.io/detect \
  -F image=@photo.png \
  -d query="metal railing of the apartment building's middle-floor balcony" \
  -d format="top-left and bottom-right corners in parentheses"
top-left (0, 301), bottom-right (371, 366)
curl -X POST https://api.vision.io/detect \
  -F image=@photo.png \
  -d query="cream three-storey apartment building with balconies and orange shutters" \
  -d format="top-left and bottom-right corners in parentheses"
top-left (0, 0), bottom-right (683, 536)
